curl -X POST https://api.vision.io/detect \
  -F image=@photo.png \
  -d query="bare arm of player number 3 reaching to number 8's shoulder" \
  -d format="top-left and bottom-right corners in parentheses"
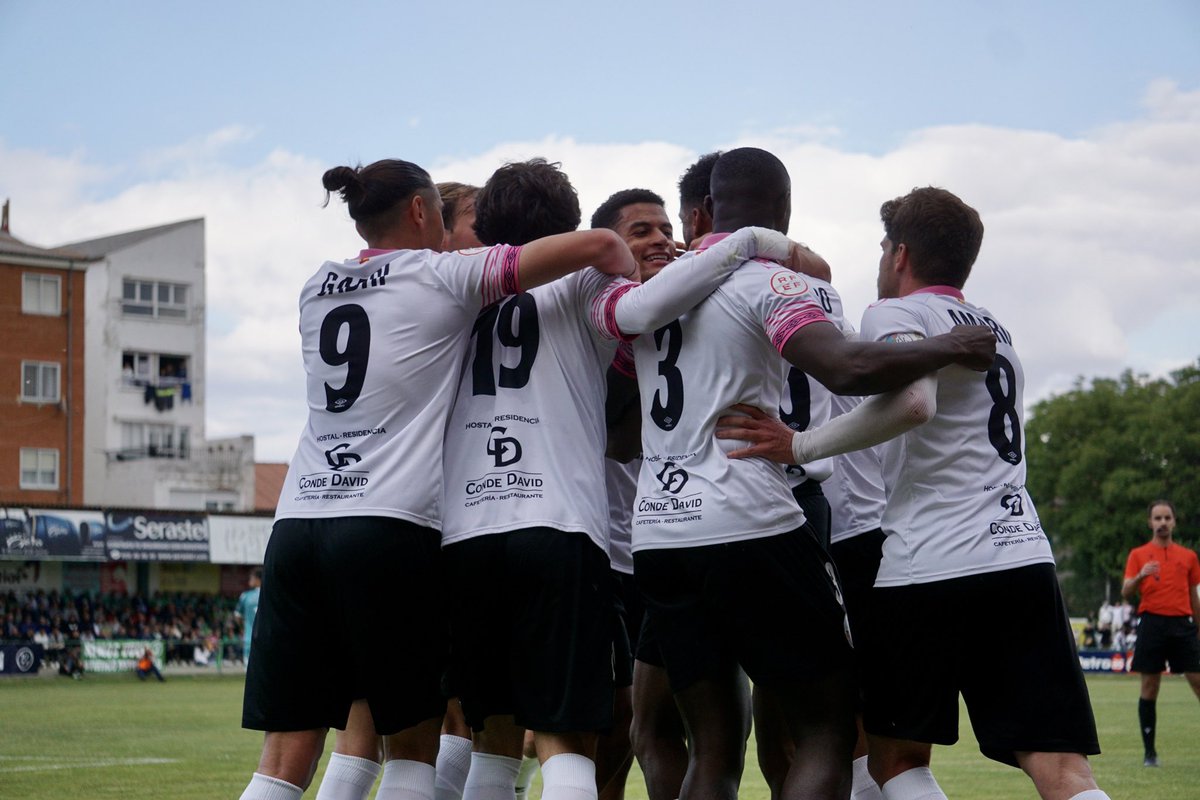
top-left (782, 323), bottom-right (996, 395)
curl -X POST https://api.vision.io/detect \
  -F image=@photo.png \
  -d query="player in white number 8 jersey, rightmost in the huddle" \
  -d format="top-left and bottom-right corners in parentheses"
top-left (710, 187), bottom-right (1108, 800)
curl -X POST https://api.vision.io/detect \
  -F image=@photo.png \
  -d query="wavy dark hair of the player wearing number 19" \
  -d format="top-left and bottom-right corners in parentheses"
top-left (475, 158), bottom-right (582, 245)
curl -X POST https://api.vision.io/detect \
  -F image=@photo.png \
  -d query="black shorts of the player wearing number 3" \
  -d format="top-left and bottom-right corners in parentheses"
top-left (634, 524), bottom-right (853, 692)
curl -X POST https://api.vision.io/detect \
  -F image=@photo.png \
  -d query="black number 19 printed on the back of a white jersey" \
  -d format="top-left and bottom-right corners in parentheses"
top-left (470, 294), bottom-right (540, 395)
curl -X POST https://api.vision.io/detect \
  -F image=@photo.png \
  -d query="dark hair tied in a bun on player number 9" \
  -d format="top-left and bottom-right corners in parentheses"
top-left (320, 158), bottom-right (437, 240)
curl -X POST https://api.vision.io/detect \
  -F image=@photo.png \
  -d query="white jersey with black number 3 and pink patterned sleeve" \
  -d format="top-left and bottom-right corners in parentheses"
top-left (632, 237), bottom-right (826, 553)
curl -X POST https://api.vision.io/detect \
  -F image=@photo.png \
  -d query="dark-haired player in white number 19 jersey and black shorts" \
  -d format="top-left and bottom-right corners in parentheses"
top-left (443, 160), bottom-right (788, 800)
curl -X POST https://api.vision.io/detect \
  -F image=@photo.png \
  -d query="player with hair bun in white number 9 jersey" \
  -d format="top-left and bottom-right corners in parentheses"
top-left (242, 160), bottom-right (635, 800)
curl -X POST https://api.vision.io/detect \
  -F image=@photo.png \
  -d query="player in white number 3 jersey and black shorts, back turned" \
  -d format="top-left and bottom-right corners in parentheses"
top-left (634, 148), bottom-right (995, 800)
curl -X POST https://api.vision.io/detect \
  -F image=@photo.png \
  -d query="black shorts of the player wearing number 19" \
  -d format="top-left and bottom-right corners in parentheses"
top-left (444, 528), bottom-right (613, 733)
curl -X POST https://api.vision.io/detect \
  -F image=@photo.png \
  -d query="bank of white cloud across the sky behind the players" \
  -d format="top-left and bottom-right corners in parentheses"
top-left (0, 82), bottom-right (1200, 461)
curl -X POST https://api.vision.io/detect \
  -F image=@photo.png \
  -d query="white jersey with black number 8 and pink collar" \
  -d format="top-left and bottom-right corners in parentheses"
top-left (863, 287), bottom-right (1054, 587)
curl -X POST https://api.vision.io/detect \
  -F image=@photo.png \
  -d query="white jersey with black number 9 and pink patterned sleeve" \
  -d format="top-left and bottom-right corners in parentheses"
top-left (276, 246), bottom-right (521, 528)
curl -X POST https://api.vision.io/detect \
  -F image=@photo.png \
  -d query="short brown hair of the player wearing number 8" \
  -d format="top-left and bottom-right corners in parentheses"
top-left (880, 186), bottom-right (983, 289)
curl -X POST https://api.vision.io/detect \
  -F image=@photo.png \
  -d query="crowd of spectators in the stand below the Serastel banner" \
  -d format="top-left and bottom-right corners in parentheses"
top-left (0, 590), bottom-right (242, 668)
